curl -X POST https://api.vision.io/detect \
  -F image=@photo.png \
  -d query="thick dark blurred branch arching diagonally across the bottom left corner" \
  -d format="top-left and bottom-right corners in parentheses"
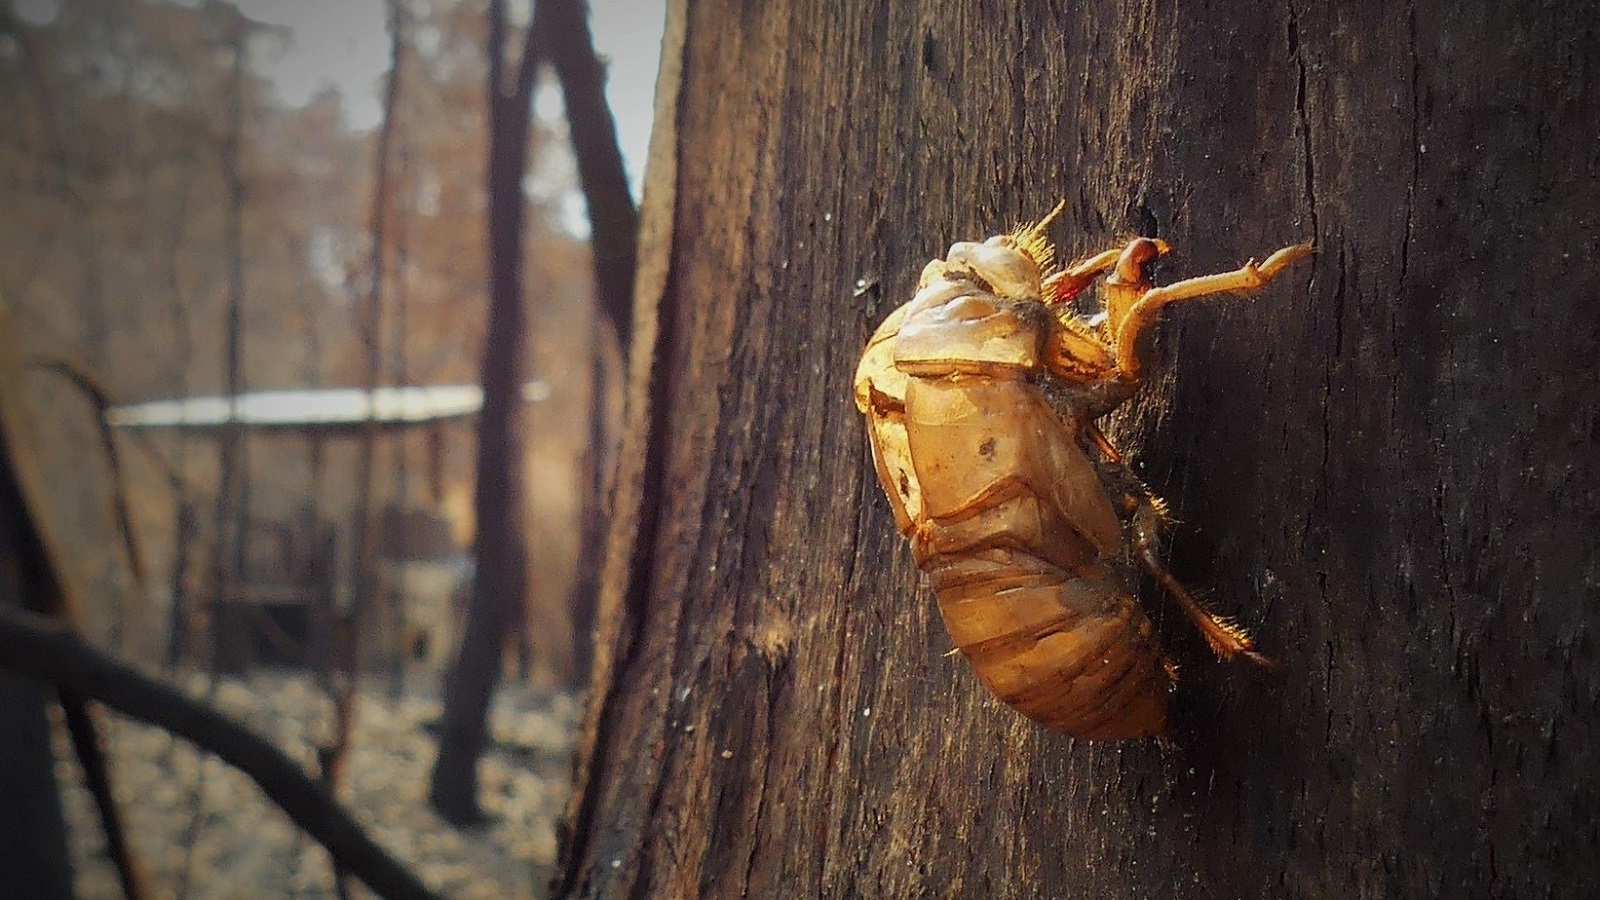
top-left (0, 607), bottom-right (437, 900)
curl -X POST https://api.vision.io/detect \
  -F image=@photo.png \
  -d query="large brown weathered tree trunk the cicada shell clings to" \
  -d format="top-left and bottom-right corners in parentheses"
top-left (558, 0), bottom-right (1600, 897)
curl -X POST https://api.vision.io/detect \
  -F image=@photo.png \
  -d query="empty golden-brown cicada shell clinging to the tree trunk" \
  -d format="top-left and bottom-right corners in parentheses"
top-left (854, 207), bottom-right (1310, 740)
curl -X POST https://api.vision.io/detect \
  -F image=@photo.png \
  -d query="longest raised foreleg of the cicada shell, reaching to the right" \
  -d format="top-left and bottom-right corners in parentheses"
top-left (1106, 240), bottom-right (1312, 380)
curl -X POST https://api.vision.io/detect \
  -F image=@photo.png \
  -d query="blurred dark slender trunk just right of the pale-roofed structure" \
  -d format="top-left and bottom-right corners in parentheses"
top-left (429, 0), bottom-right (538, 825)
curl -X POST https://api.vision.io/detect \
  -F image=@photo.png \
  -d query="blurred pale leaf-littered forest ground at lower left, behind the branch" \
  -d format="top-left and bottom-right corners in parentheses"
top-left (56, 671), bottom-right (578, 900)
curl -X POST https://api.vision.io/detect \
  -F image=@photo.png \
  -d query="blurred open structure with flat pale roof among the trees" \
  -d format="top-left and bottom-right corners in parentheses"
top-left (106, 381), bottom-right (549, 671)
